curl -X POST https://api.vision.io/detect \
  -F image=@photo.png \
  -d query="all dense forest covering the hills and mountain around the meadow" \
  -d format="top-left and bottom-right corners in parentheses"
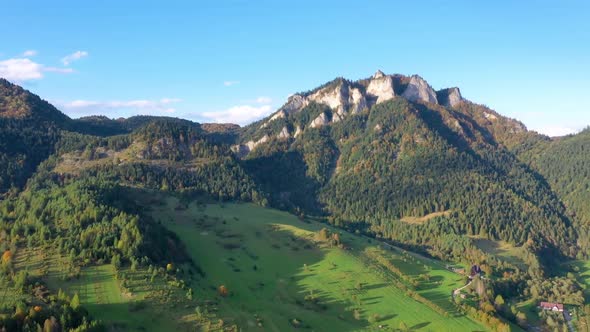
top-left (0, 76), bottom-right (590, 330)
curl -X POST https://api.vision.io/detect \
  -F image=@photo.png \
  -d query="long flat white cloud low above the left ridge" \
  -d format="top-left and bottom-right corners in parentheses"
top-left (54, 98), bottom-right (182, 117)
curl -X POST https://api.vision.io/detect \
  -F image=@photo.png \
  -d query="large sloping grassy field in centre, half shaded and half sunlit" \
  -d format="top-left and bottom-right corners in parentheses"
top-left (139, 192), bottom-right (485, 331)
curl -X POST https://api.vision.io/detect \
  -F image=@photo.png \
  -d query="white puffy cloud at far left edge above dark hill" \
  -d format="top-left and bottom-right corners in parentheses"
top-left (0, 58), bottom-right (74, 83)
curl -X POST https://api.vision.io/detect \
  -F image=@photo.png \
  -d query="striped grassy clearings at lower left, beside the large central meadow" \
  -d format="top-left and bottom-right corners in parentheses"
top-left (9, 241), bottom-right (198, 332)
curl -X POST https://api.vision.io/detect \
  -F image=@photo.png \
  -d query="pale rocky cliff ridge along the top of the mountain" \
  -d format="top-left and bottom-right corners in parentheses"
top-left (232, 70), bottom-right (529, 157)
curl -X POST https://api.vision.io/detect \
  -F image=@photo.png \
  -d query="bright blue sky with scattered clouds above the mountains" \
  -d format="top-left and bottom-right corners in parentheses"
top-left (0, 0), bottom-right (590, 134)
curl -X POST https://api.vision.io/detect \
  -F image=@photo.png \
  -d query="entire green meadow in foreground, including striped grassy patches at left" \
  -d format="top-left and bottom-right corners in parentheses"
top-left (0, 191), bottom-right (498, 331)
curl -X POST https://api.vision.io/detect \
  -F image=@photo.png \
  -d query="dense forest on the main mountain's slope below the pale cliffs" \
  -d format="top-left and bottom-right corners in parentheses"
top-left (239, 99), bottom-right (576, 264)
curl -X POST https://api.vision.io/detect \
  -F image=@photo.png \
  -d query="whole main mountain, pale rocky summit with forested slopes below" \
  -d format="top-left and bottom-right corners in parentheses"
top-left (234, 73), bottom-right (576, 268)
